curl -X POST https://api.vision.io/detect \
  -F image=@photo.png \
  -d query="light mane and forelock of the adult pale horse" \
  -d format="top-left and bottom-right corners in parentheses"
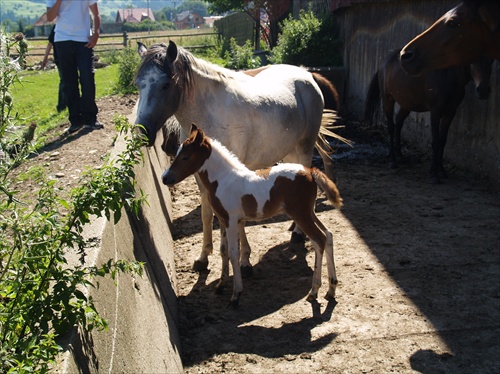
top-left (137, 43), bottom-right (233, 96)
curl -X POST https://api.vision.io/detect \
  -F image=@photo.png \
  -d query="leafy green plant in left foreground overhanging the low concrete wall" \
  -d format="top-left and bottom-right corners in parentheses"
top-left (0, 33), bottom-right (145, 373)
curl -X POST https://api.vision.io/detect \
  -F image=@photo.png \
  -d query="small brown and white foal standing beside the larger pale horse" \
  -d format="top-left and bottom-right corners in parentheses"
top-left (162, 124), bottom-right (342, 307)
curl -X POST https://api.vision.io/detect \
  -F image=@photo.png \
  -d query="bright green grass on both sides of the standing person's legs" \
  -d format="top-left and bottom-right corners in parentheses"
top-left (11, 64), bottom-right (118, 146)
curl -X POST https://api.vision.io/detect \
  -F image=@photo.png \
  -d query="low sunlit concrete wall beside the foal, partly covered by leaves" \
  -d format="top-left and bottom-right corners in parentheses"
top-left (54, 128), bottom-right (183, 373)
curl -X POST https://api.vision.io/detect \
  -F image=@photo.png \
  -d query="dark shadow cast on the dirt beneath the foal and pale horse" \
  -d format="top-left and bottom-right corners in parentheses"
top-left (179, 243), bottom-right (337, 366)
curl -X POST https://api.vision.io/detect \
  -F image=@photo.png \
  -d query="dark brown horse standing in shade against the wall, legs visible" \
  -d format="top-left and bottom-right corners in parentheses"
top-left (365, 50), bottom-right (492, 183)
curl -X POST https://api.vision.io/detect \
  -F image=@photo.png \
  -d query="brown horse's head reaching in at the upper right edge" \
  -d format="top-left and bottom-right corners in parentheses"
top-left (400, 0), bottom-right (500, 75)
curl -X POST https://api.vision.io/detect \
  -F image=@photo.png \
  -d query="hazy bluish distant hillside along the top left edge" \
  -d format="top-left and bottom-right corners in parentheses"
top-left (0, 0), bottom-right (182, 24)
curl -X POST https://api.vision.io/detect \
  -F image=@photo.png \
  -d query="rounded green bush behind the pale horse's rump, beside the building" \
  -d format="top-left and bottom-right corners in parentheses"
top-left (270, 10), bottom-right (342, 67)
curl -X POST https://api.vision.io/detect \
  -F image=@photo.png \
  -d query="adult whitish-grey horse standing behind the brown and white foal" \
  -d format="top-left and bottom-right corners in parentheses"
top-left (135, 42), bottom-right (344, 273)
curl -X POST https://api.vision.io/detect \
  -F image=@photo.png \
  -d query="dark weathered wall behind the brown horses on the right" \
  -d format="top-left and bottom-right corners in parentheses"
top-left (334, 0), bottom-right (500, 186)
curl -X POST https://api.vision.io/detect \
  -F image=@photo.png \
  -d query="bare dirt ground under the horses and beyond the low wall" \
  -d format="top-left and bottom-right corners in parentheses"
top-left (13, 97), bottom-right (500, 373)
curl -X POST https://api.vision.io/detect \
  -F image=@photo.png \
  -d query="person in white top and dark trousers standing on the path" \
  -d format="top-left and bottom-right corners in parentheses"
top-left (46, 0), bottom-right (104, 134)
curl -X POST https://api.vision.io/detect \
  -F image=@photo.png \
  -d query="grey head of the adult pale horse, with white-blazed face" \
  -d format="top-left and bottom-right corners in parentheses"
top-left (135, 41), bottom-right (185, 146)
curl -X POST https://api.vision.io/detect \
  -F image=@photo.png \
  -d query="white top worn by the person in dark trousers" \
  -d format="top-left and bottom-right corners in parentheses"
top-left (46, 0), bottom-right (99, 42)
